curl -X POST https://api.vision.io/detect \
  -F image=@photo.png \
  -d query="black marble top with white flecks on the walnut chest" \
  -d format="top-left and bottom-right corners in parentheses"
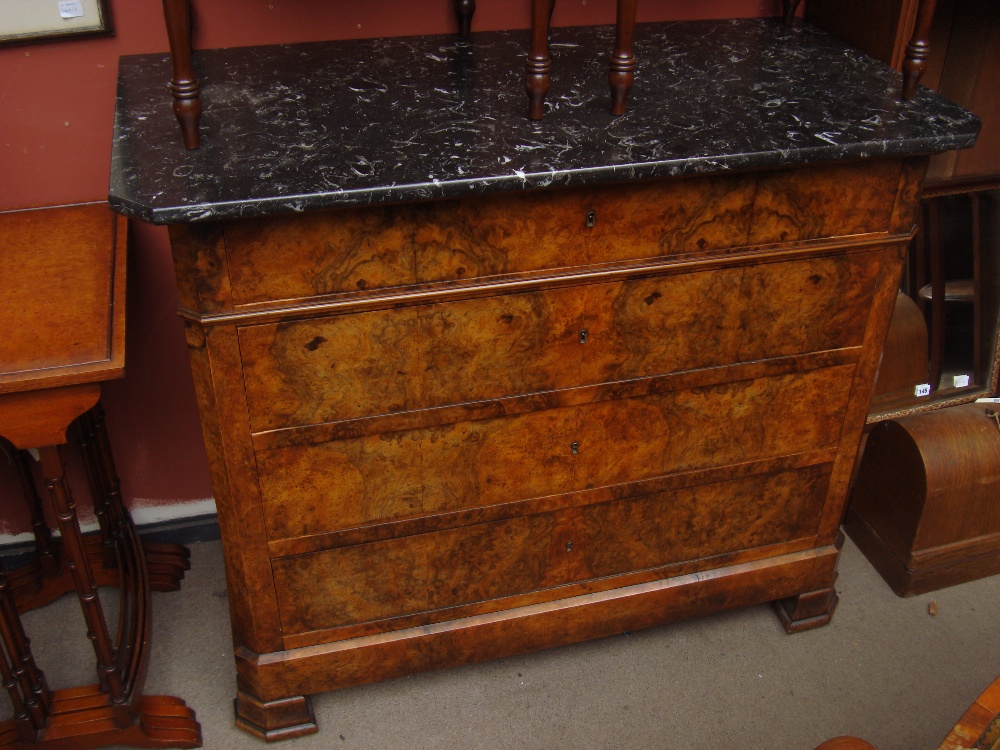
top-left (109, 19), bottom-right (979, 223)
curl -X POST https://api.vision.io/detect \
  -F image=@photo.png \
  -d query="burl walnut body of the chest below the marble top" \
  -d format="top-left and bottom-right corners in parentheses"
top-left (171, 159), bottom-right (926, 739)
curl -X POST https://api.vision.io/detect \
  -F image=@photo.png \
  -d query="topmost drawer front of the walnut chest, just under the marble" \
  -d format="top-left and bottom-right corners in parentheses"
top-left (224, 161), bottom-right (901, 306)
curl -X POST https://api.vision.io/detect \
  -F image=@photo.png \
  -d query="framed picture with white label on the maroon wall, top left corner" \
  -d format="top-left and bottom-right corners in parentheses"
top-left (0, 0), bottom-right (114, 45)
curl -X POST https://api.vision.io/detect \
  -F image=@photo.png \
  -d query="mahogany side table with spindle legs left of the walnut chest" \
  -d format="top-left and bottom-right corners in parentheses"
top-left (0, 203), bottom-right (201, 750)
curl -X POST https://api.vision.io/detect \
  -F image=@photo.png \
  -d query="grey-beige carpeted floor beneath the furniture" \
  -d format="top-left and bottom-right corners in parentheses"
top-left (7, 541), bottom-right (1000, 750)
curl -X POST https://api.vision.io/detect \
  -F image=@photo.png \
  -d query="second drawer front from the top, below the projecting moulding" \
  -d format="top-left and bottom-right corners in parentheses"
top-left (240, 252), bottom-right (880, 432)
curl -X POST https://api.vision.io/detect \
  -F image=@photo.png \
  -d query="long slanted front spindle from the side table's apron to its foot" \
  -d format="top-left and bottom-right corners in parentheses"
top-left (38, 445), bottom-right (132, 727)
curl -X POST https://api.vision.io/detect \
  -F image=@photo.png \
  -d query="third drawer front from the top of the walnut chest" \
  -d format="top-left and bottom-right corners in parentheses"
top-left (257, 365), bottom-right (854, 540)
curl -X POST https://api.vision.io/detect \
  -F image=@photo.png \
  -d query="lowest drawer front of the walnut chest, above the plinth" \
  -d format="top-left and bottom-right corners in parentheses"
top-left (272, 464), bottom-right (829, 636)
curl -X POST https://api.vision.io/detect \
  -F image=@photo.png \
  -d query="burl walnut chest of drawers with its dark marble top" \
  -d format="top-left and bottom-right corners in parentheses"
top-left (112, 16), bottom-right (977, 739)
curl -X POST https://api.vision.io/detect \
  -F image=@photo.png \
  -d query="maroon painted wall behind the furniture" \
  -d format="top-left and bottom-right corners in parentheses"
top-left (0, 0), bottom-right (796, 542)
